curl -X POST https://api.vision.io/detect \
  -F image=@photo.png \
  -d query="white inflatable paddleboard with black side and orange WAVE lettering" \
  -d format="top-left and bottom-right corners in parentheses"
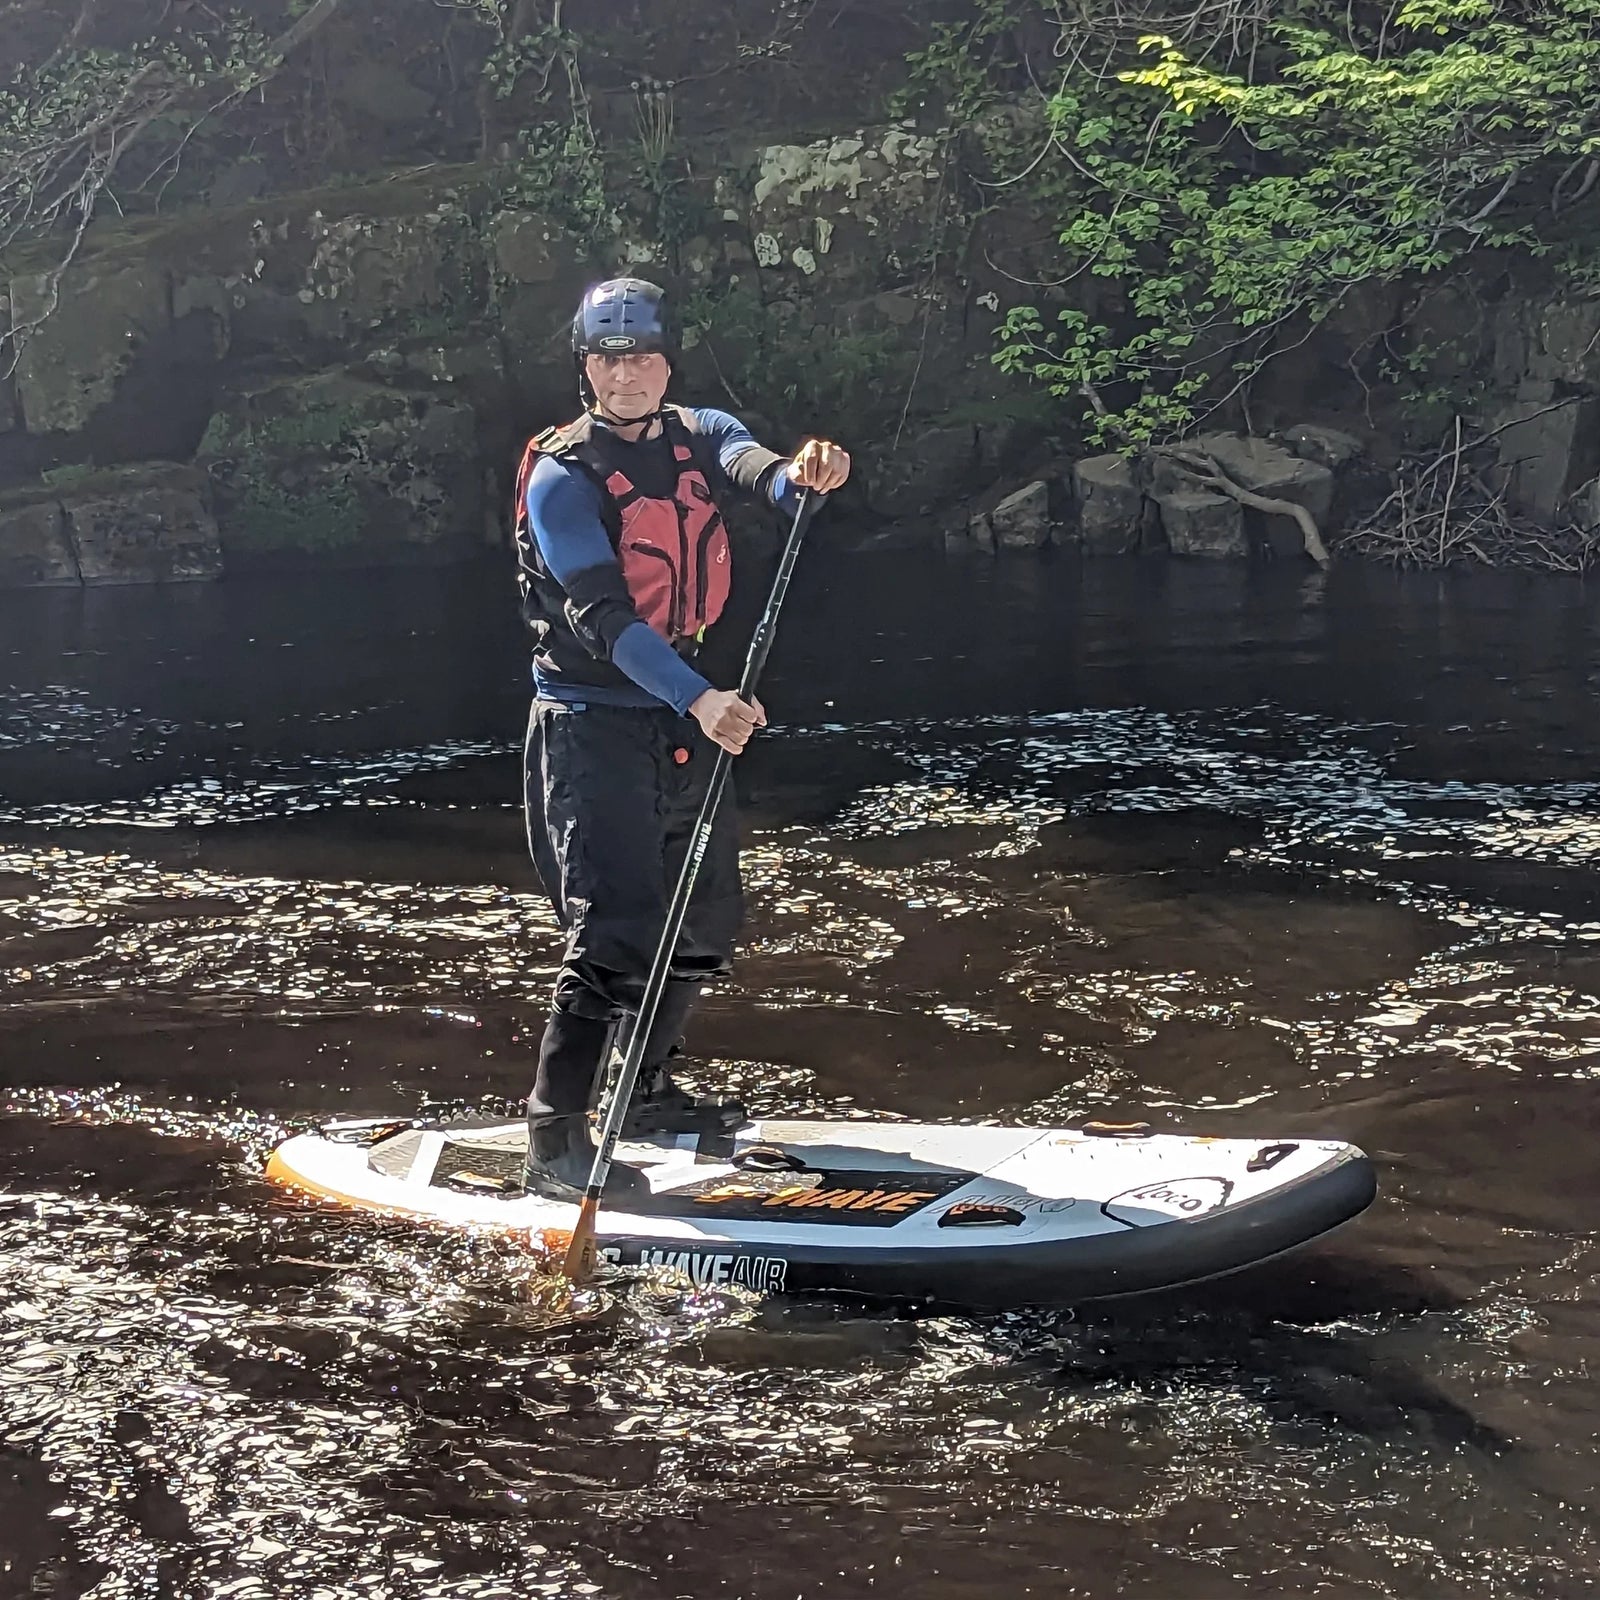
top-left (267, 1117), bottom-right (1376, 1306)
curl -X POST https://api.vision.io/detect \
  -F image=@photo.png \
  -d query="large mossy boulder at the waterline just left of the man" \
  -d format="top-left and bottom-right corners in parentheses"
top-left (200, 371), bottom-right (485, 565)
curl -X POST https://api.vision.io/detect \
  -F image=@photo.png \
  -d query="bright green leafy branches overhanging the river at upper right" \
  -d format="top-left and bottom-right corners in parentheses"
top-left (914, 0), bottom-right (1600, 446)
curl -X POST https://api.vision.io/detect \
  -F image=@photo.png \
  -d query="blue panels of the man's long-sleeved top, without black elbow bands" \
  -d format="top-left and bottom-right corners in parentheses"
top-left (526, 408), bottom-right (800, 715)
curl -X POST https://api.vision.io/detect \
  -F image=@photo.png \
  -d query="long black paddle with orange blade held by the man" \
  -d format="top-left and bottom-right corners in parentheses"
top-left (562, 490), bottom-right (821, 1283)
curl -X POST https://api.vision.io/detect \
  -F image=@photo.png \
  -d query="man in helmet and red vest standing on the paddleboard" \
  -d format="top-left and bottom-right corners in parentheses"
top-left (517, 278), bottom-right (850, 1200)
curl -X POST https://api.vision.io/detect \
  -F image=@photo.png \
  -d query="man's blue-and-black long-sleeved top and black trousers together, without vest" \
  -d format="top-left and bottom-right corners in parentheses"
top-left (517, 411), bottom-right (792, 1115)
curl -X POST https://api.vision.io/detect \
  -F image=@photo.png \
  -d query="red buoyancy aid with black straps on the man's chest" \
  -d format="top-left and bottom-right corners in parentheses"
top-left (517, 406), bottom-right (733, 643)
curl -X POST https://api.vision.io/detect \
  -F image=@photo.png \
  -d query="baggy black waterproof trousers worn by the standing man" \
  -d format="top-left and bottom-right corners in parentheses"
top-left (523, 701), bottom-right (744, 1115)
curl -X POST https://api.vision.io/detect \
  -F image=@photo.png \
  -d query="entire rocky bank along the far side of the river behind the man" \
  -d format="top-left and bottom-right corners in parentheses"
top-left (0, 93), bottom-right (1600, 582)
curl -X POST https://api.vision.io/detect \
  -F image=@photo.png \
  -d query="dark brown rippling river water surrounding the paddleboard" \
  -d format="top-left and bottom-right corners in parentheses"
top-left (0, 558), bottom-right (1600, 1600)
